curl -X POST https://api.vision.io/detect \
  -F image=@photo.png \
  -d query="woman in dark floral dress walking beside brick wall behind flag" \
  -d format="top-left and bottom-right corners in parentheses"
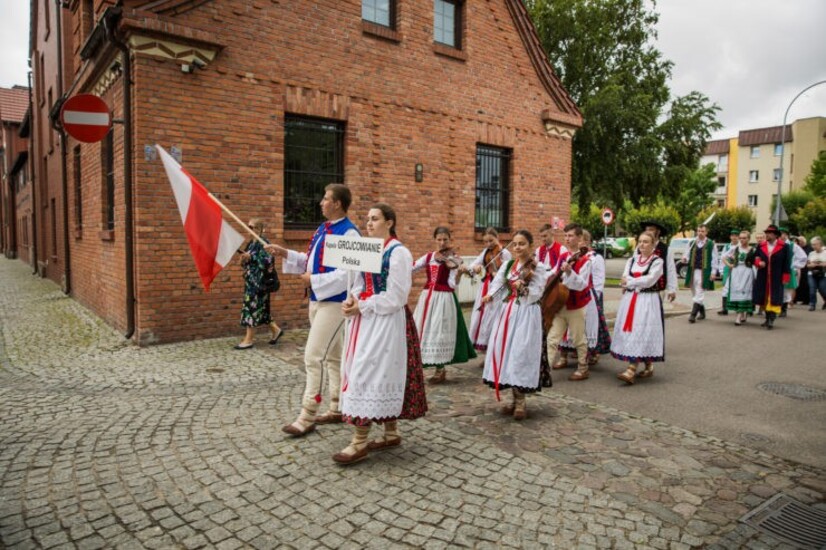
top-left (235, 218), bottom-right (282, 350)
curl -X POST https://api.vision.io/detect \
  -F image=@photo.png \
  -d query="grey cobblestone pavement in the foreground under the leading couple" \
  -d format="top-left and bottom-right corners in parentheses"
top-left (0, 259), bottom-right (826, 550)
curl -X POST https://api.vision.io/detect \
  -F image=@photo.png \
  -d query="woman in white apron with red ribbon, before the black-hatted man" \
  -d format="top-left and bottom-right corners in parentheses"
top-left (611, 232), bottom-right (665, 384)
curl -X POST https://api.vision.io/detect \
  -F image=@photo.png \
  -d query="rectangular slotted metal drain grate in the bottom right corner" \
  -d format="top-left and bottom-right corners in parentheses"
top-left (740, 493), bottom-right (826, 550)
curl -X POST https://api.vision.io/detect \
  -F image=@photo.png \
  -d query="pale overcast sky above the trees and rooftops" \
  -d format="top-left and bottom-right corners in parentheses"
top-left (0, 0), bottom-right (826, 139)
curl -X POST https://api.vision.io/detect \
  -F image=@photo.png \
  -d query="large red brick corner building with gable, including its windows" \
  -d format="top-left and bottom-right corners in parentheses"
top-left (33, 0), bottom-right (581, 343)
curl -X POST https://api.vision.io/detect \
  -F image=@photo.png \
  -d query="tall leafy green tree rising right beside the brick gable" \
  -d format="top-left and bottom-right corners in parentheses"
top-left (526, 0), bottom-right (718, 206)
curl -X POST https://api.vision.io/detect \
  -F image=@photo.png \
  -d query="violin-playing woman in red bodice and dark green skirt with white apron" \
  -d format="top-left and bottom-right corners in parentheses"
top-left (413, 227), bottom-right (476, 384)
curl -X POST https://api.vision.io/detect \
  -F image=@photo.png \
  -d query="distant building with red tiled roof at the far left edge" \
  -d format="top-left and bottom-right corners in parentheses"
top-left (0, 86), bottom-right (32, 262)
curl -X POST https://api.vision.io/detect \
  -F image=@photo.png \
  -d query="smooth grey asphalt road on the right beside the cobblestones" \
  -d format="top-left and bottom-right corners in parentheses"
top-left (554, 304), bottom-right (826, 468)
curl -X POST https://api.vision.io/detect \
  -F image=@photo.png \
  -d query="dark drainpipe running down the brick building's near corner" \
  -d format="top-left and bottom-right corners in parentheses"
top-left (105, 8), bottom-right (135, 340)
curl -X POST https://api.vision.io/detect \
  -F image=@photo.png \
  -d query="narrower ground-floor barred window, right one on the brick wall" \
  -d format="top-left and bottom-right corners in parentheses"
top-left (475, 145), bottom-right (511, 231)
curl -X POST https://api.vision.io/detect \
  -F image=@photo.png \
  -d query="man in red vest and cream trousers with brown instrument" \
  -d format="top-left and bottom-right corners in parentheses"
top-left (548, 223), bottom-right (593, 382)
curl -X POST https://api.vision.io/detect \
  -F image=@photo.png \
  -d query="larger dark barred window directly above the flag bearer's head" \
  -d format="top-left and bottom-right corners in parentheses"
top-left (284, 115), bottom-right (344, 229)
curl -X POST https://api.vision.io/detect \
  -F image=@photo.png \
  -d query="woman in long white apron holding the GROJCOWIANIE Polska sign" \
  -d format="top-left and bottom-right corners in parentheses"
top-left (333, 203), bottom-right (427, 464)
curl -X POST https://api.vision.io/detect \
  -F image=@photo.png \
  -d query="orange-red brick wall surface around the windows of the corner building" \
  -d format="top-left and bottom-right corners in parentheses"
top-left (62, 0), bottom-right (571, 343)
